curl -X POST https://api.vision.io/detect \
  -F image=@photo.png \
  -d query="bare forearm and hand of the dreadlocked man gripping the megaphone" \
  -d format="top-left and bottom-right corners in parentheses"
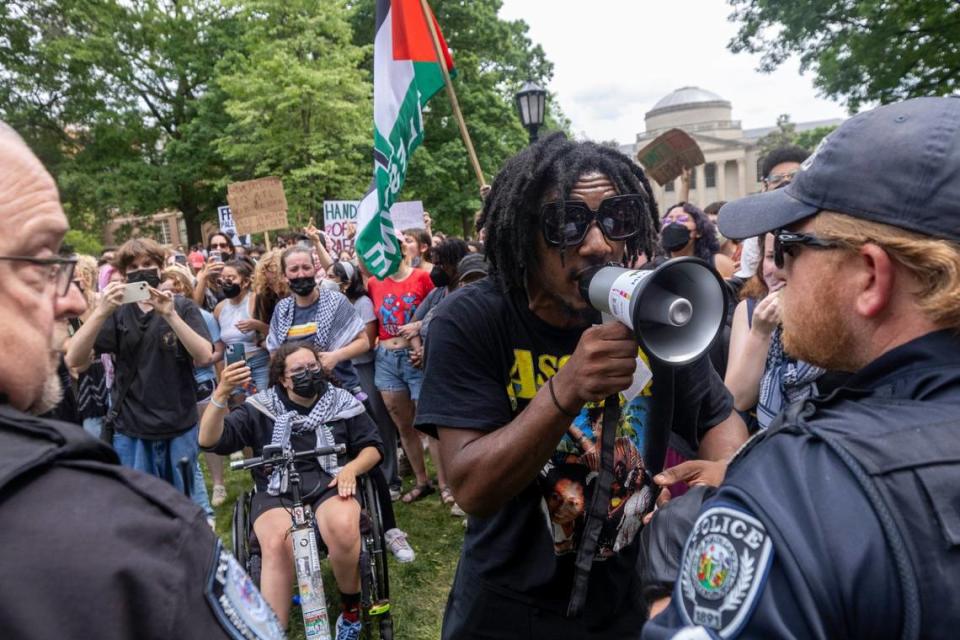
top-left (438, 323), bottom-right (637, 516)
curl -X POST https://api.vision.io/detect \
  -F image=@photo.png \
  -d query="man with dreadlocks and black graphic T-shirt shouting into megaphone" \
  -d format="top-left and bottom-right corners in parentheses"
top-left (417, 134), bottom-right (746, 640)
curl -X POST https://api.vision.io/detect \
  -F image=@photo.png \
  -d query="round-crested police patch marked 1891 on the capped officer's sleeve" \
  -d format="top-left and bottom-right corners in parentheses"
top-left (675, 504), bottom-right (773, 638)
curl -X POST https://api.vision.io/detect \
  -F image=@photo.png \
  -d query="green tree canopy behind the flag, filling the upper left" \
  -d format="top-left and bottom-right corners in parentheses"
top-left (0, 0), bottom-right (566, 242)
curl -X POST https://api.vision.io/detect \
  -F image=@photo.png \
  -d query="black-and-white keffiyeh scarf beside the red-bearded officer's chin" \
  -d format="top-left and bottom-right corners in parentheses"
top-left (757, 327), bottom-right (825, 429)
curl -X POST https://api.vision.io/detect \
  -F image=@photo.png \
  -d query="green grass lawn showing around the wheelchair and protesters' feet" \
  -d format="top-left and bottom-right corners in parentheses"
top-left (211, 456), bottom-right (464, 640)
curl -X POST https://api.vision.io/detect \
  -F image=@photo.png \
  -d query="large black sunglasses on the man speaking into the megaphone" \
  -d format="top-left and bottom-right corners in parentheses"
top-left (540, 194), bottom-right (646, 247)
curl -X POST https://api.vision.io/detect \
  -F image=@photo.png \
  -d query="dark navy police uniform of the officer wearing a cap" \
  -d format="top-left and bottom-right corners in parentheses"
top-left (643, 331), bottom-right (960, 640)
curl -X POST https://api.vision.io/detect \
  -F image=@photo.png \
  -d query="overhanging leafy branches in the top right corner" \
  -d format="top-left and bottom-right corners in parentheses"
top-left (728, 0), bottom-right (960, 112)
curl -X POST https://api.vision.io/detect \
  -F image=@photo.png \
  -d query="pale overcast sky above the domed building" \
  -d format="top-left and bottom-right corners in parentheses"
top-left (500, 0), bottom-right (846, 143)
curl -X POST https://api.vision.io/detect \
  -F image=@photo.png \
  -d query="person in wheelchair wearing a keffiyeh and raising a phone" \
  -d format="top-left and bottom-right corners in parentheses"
top-left (200, 343), bottom-right (382, 639)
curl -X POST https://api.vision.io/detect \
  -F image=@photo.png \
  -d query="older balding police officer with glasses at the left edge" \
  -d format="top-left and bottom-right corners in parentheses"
top-left (0, 123), bottom-right (283, 638)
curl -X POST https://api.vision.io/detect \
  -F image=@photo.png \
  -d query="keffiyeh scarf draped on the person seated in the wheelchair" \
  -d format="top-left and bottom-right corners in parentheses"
top-left (247, 386), bottom-right (364, 496)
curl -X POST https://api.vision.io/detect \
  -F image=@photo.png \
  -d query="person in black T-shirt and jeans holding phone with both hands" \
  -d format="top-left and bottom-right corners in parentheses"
top-left (66, 238), bottom-right (214, 490)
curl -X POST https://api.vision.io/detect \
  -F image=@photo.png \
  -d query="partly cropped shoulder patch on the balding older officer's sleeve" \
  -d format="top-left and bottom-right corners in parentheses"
top-left (206, 541), bottom-right (286, 640)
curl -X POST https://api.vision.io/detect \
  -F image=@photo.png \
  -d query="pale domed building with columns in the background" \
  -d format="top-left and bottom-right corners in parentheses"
top-left (625, 87), bottom-right (841, 211)
